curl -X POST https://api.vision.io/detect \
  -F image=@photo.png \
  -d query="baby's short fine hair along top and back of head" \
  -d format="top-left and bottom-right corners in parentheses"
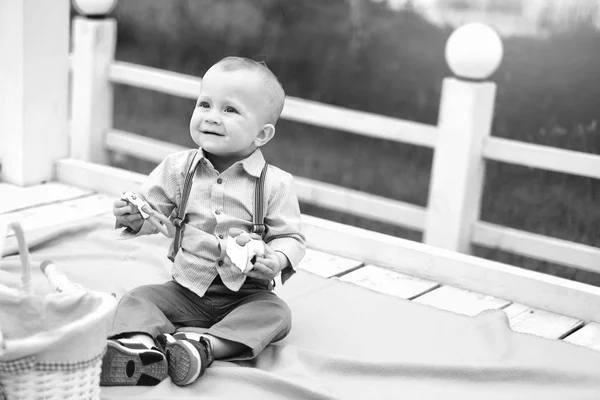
top-left (215, 57), bottom-right (285, 125)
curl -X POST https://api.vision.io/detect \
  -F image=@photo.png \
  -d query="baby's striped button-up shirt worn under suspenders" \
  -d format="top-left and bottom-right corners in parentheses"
top-left (117, 149), bottom-right (305, 296)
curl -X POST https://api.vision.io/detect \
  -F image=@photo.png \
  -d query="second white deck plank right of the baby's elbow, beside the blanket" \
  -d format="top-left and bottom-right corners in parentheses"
top-left (340, 265), bottom-right (439, 299)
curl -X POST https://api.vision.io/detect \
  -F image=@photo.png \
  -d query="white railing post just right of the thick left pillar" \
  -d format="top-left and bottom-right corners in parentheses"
top-left (71, 0), bottom-right (117, 163)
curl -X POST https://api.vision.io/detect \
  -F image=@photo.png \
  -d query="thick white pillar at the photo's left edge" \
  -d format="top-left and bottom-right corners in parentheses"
top-left (0, 0), bottom-right (69, 186)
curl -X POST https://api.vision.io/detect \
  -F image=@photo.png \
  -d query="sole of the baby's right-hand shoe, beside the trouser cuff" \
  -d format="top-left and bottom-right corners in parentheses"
top-left (163, 340), bottom-right (202, 386)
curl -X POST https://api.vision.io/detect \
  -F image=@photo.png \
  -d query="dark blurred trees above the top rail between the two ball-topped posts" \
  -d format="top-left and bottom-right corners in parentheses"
top-left (116, 0), bottom-right (447, 123)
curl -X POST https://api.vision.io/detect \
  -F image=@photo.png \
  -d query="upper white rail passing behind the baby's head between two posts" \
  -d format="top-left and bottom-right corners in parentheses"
top-left (109, 61), bottom-right (437, 147)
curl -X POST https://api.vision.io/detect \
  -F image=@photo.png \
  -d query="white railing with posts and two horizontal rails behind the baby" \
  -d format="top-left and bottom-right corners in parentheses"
top-left (62, 17), bottom-right (600, 272)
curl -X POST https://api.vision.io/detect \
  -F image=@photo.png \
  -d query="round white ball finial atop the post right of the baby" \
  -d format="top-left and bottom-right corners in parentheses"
top-left (446, 22), bottom-right (504, 79)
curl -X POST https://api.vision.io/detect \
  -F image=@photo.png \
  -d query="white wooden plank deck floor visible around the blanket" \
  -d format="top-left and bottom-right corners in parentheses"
top-left (0, 182), bottom-right (600, 350)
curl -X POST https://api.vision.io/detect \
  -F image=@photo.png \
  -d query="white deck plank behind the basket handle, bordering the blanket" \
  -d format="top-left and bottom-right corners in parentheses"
top-left (0, 194), bottom-right (114, 254)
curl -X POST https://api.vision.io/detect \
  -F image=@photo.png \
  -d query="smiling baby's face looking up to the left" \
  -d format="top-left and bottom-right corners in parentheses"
top-left (190, 65), bottom-right (274, 160)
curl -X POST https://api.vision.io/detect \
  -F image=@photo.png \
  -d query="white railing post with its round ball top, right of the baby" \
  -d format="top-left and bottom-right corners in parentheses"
top-left (423, 23), bottom-right (503, 253)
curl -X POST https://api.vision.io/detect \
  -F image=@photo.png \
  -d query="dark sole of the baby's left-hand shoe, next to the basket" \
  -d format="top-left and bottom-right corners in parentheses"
top-left (100, 341), bottom-right (168, 386)
